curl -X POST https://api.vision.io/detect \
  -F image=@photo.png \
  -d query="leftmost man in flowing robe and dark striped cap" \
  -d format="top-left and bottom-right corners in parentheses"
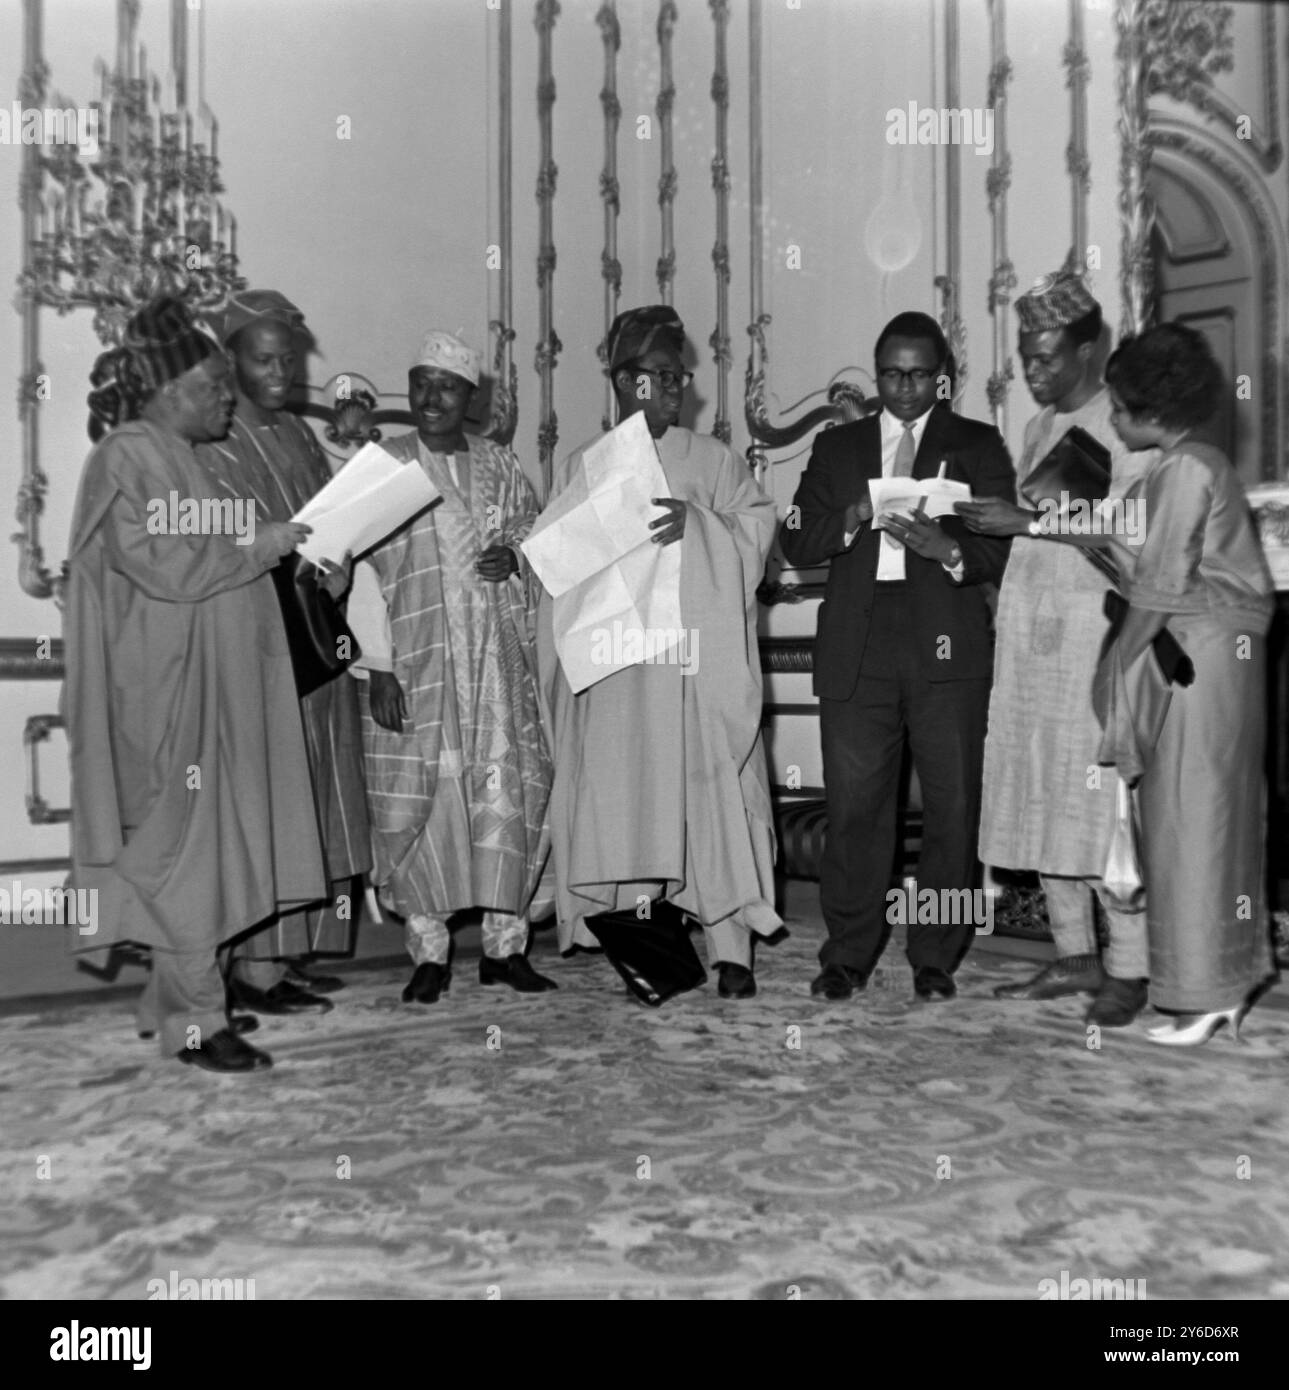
top-left (64, 300), bottom-right (325, 1072)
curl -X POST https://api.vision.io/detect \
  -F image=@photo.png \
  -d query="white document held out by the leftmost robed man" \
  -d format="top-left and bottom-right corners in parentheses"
top-left (291, 443), bottom-right (442, 564)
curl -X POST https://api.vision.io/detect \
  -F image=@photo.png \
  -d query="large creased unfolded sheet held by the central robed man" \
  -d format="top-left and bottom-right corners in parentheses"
top-left (523, 414), bottom-right (684, 694)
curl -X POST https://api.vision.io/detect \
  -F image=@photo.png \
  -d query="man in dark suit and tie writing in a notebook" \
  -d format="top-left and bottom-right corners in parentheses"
top-left (780, 313), bottom-right (1015, 999)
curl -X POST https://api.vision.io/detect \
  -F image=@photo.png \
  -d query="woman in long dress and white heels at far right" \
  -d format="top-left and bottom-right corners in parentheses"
top-left (1093, 324), bottom-right (1274, 1047)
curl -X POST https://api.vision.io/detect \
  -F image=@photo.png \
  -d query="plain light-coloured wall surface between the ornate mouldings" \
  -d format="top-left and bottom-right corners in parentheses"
top-left (0, 8), bottom-right (1289, 989)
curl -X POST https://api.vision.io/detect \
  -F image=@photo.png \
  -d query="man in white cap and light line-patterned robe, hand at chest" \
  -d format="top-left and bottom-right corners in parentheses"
top-left (349, 329), bottom-right (556, 1004)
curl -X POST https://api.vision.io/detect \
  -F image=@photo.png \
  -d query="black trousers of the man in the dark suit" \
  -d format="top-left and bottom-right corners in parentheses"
top-left (819, 584), bottom-right (990, 974)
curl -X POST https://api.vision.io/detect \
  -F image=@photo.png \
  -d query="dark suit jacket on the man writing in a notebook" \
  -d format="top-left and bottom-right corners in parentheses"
top-left (779, 404), bottom-right (1016, 699)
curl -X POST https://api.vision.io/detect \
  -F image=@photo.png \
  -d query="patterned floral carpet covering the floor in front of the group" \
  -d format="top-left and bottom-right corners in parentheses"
top-left (0, 913), bottom-right (1289, 1300)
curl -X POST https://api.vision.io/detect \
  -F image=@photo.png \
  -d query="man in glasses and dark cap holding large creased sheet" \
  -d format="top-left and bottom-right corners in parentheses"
top-left (538, 306), bottom-right (783, 1004)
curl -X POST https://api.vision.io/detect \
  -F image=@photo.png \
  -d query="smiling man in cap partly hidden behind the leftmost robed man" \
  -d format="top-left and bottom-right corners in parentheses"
top-left (197, 289), bottom-right (371, 1013)
